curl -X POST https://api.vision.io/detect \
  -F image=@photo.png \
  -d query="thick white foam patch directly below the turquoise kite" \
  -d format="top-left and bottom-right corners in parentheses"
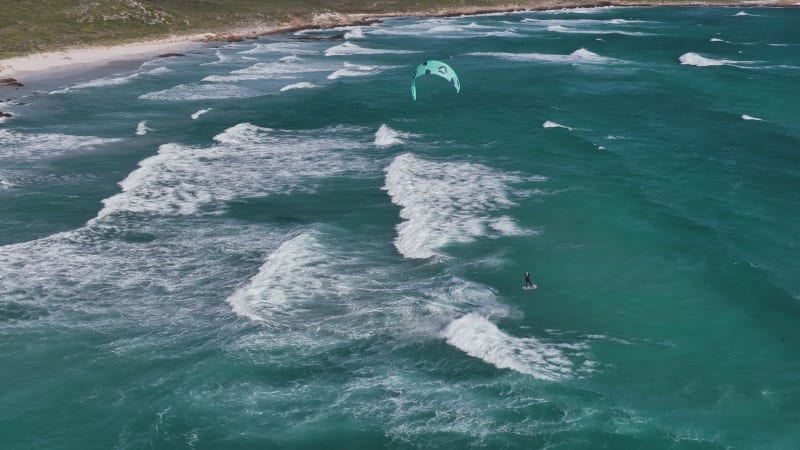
top-left (383, 153), bottom-right (530, 258)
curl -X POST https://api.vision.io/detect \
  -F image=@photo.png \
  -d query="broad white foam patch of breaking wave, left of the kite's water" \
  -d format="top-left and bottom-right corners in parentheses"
top-left (94, 123), bottom-right (366, 221)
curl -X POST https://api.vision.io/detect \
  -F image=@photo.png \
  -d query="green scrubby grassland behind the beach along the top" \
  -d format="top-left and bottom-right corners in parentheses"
top-left (0, 0), bottom-right (776, 58)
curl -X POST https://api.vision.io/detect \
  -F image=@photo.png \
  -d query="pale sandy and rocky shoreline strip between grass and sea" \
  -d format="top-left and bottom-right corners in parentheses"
top-left (0, 0), bottom-right (800, 89)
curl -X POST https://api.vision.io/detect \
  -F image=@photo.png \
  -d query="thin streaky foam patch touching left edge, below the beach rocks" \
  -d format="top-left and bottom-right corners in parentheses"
top-left (0, 129), bottom-right (123, 161)
